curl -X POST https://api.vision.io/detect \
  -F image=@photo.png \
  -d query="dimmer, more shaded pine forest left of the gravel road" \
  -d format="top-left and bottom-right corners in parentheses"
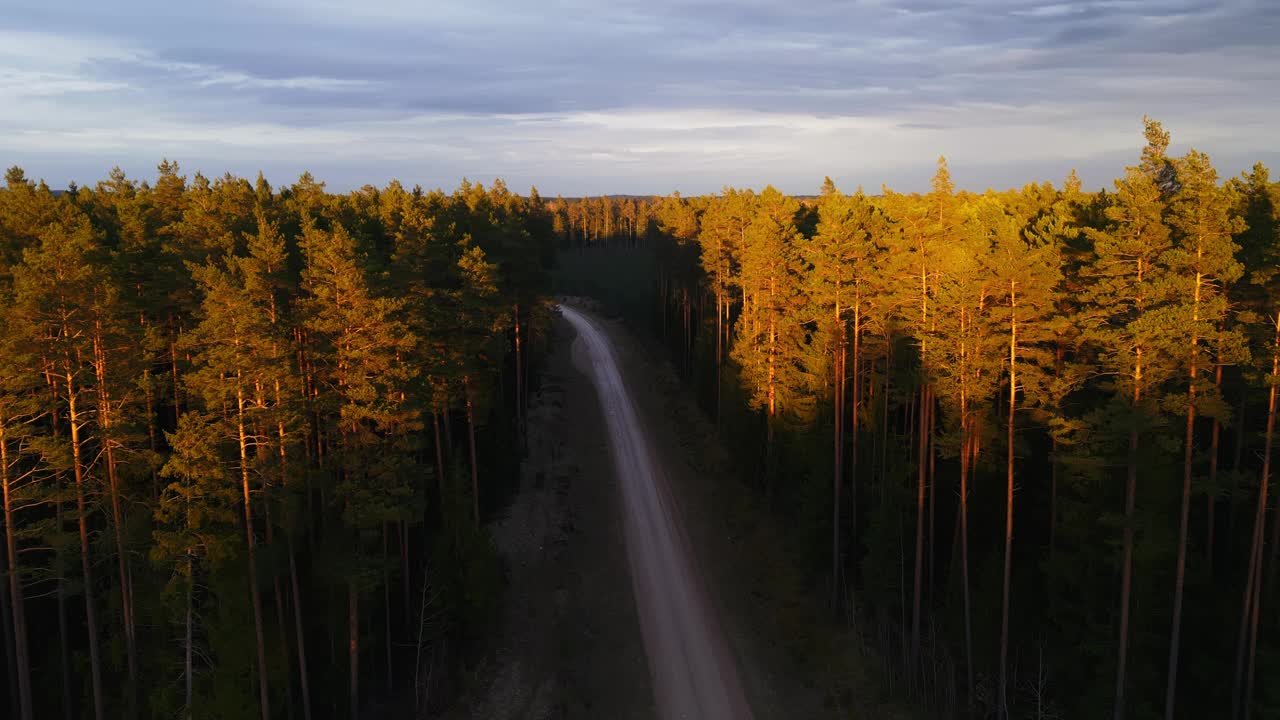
top-left (0, 161), bottom-right (554, 720)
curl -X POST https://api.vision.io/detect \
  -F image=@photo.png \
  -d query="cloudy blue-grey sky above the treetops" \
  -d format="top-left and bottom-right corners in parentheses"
top-left (0, 0), bottom-right (1280, 196)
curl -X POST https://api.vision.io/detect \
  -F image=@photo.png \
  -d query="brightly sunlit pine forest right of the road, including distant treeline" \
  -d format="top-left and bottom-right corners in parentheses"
top-left (553, 119), bottom-right (1280, 720)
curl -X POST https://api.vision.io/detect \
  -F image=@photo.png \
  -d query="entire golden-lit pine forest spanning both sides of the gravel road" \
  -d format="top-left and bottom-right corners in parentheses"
top-left (0, 119), bottom-right (1280, 720)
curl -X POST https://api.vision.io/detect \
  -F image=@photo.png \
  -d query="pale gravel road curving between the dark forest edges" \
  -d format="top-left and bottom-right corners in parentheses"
top-left (559, 305), bottom-right (751, 720)
